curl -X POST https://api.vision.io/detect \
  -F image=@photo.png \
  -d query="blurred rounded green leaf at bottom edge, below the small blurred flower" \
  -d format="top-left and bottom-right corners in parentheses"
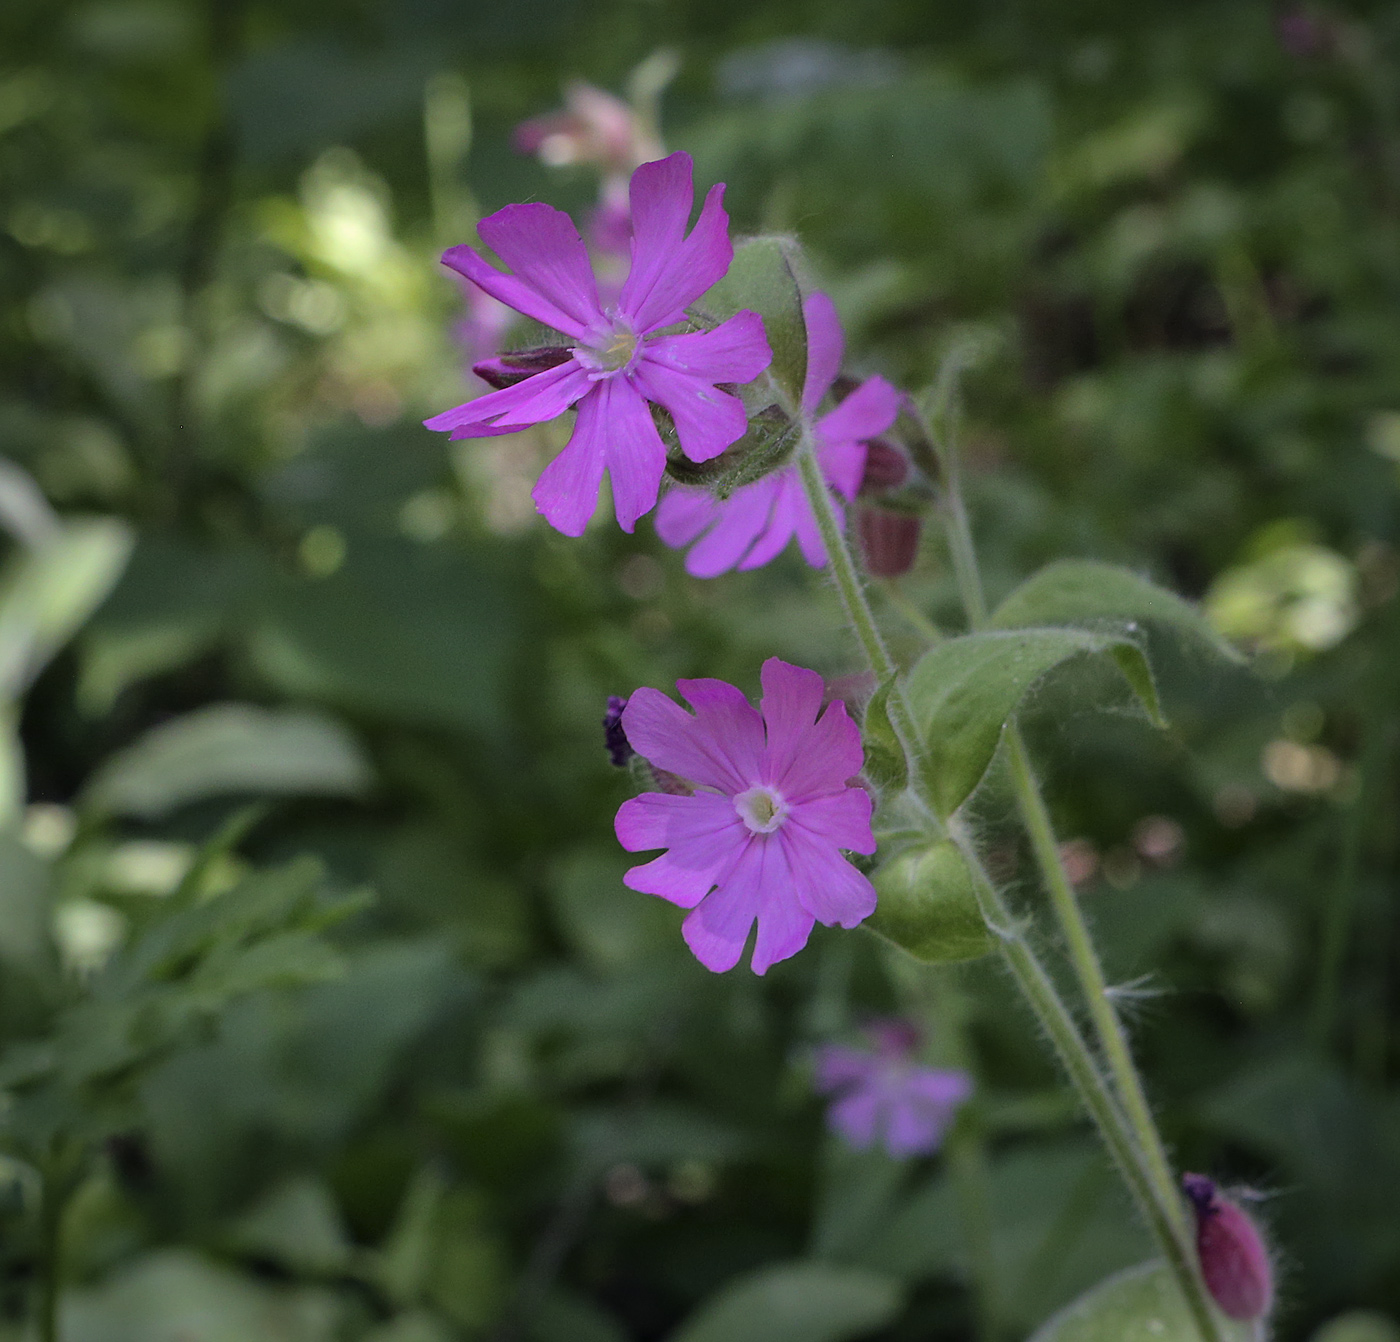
top-left (669, 1262), bottom-right (903, 1342)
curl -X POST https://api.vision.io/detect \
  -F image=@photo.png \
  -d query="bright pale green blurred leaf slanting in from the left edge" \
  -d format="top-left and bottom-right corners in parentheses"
top-left (0, 518), bottom-right (136, 698)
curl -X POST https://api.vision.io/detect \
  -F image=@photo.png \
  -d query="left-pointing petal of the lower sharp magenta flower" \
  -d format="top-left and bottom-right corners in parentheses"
top-left (615, 792), bottom-right (749, 908)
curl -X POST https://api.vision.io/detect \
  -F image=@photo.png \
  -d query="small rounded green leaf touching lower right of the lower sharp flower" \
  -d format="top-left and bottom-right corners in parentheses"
top-left (867, 840), bottom-right (994, 964)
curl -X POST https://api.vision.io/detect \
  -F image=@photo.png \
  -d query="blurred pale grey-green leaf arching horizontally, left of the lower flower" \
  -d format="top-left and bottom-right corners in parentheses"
top-left (84, 704), bottom-right (372, 820)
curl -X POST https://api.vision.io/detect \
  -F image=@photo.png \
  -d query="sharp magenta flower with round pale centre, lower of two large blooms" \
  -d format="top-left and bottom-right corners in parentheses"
top-left (616, 658), bottom-right (875, 974)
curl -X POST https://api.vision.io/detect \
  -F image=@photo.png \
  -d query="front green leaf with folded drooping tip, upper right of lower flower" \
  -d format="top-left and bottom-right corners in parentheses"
top-left (906, 628), bottom-right (1165, 816)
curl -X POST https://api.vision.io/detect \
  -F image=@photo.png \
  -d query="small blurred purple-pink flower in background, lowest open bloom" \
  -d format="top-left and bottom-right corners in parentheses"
top-left (816, 1020), bottom-right (972, 1160)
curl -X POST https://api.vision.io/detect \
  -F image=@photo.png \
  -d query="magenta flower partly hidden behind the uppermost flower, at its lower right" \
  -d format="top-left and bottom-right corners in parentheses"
top-left (657, 294), bottom-right (900, 578)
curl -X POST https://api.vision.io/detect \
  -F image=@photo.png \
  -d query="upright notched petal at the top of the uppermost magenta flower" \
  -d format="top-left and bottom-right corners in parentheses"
top-left (617, 154), bottom-right (734, 333)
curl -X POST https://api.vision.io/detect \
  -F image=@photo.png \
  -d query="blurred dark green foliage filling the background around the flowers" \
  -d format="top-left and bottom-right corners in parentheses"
top-left (0, 0), bottom-right (1400, 1342)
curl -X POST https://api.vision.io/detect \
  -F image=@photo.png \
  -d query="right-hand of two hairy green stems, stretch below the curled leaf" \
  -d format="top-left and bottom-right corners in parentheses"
top-left (1007, 723), bottom-right (1187, 1233)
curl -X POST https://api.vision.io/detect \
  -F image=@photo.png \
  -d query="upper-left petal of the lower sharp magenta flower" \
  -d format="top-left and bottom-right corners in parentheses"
top-left (622, 680), bottom-right (763, 796)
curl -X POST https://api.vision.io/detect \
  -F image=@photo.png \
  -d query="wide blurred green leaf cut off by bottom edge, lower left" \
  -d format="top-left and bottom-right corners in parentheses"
top-left (60, 1248), bottom-right (346, 1342)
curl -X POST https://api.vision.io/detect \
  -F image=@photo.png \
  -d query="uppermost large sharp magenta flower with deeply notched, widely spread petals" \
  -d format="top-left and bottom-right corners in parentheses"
top-left (426, 154), bottom-right (773, 536)
